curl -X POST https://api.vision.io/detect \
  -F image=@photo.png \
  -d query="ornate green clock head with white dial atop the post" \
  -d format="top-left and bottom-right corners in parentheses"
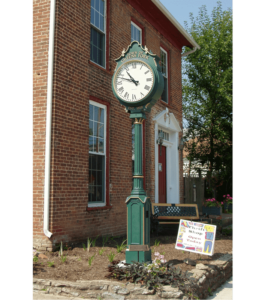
top-left (112, 41), bottom-right (164, 111)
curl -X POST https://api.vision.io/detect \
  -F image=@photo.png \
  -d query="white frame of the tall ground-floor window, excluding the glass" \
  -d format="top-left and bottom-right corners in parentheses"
top-left (88, 100), bottom-right (107, 207)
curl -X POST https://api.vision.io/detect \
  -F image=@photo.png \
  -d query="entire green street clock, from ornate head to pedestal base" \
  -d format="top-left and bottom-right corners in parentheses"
top-left (112, 41), bottom-right (164, 264)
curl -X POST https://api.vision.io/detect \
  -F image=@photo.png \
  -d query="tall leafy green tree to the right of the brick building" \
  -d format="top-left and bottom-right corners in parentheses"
top-left (183, 1), bottom-right (233, 197)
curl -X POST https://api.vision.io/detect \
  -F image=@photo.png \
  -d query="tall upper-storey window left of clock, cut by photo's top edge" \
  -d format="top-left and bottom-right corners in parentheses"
top-left (90, 0), bottom-right (106, 68)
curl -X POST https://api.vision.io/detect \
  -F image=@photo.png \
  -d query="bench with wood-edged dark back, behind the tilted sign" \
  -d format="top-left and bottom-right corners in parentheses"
top-left (151, 203), bottom-right (208, 233)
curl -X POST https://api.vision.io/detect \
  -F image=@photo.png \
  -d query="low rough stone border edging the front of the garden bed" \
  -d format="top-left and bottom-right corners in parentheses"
top-left (32, 253), bottom-right (233, 300)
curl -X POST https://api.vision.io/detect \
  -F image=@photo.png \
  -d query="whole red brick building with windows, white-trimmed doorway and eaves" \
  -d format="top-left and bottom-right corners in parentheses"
top-left (32, 0), bottom-right (199, 250)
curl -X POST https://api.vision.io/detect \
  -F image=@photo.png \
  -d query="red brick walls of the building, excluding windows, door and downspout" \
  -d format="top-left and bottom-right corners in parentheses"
top-left (33, 0), bottom-right (183, 248)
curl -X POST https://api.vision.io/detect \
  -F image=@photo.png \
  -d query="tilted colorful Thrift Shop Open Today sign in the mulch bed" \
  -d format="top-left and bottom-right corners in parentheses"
top-left (175, 220), bottom-right (216, 256)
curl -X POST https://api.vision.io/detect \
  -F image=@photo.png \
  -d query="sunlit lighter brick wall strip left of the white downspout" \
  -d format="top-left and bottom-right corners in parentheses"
top-left (32, 0), bottom-right (50, 247)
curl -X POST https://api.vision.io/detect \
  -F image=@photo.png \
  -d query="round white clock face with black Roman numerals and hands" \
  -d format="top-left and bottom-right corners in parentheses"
top-left (114, 60), bottom-right (154, 102)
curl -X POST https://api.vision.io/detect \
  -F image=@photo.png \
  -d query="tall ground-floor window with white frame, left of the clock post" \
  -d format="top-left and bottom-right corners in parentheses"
top-left (88, 101), bottom-right (106, 206)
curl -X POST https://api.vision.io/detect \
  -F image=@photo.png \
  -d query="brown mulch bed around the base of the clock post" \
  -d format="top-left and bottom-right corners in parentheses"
top-left (33, 232), bottom-right (233, 281)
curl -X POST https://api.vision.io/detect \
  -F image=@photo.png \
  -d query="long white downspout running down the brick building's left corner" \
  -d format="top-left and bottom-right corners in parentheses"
top-left (43, 0), bottom-right (56, 238)
